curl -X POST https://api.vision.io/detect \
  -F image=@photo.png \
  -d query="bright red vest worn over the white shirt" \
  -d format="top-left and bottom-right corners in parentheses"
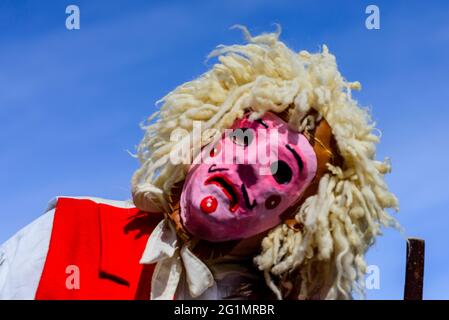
top-left (35, 198), bottom-right (162, 300)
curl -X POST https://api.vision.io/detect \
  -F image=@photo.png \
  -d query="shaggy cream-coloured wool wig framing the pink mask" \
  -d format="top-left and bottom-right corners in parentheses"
top-left (132, 26), bottom-right (398, 299)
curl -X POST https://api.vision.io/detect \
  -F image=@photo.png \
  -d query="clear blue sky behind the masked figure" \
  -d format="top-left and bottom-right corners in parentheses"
top-left (0, 0), bottom-right (449, 299)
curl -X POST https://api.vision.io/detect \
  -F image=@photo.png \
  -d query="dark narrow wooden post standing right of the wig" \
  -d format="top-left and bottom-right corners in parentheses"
top-left (404, 238), bottom-right (424, 300)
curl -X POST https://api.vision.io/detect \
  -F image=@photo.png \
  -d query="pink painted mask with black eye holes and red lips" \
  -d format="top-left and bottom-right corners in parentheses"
top-left (181, 113), bottom-right (317, 242)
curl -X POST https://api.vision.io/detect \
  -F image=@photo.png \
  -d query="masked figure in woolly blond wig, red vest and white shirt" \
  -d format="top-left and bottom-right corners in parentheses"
top-left (0, 28), bottom-right (397, 299)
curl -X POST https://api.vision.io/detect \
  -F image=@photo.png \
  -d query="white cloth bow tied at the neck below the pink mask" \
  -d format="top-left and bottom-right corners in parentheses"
top-left (140, 220), bottom-right (254, 300)
